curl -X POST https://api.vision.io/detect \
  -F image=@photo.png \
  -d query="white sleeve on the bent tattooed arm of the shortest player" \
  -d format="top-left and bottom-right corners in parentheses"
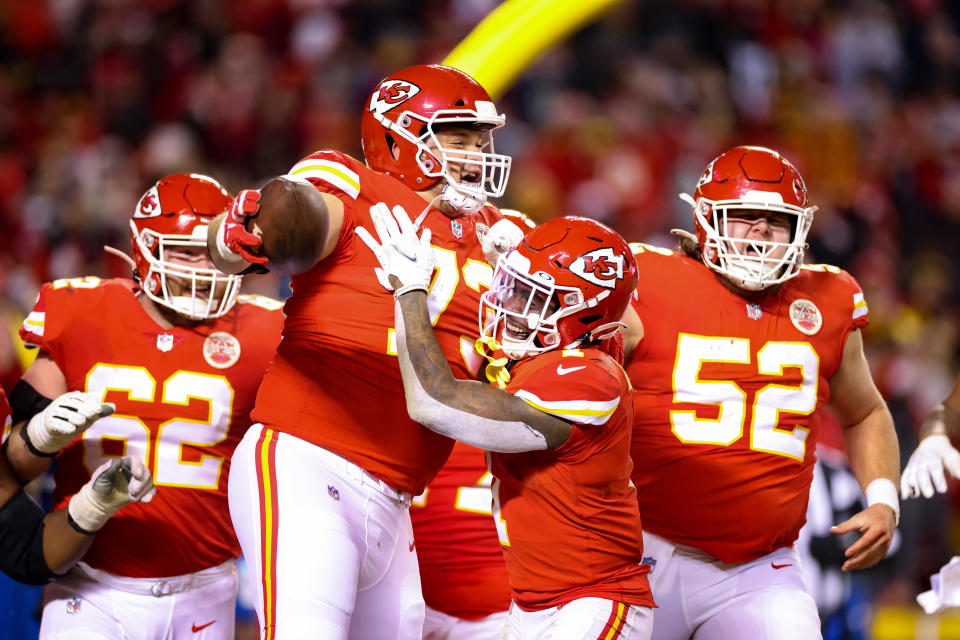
top-left (394, 302), bottom-right (547, 453)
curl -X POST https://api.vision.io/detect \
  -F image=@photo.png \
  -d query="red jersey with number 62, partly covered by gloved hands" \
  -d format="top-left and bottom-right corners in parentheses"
top-left (20, 278), bottom-right (282, 578)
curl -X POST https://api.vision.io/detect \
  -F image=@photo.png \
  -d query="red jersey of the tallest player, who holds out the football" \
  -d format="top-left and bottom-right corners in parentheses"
top-left (253, 151), bottom-right (501, 495)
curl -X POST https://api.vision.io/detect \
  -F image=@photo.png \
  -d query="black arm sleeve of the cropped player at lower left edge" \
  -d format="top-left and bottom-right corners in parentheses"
top-left (0, 491), bottom-right (57, 584)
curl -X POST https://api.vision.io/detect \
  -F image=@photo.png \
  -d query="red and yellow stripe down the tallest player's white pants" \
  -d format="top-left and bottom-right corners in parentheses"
top-left (256, 428), bottom-right (280, 640)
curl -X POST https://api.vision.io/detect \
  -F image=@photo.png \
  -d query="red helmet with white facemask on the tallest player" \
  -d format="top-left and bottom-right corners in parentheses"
top-left (360, 64), bottom-right (510, 213)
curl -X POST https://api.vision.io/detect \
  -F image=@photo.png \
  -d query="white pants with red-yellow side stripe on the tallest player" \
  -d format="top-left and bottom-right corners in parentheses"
top-left (229, 424), bottom-right (424, 640)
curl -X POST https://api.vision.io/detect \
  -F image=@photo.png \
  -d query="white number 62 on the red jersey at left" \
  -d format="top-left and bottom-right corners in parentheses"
top-left (83, 364), bottom-right (233, 489)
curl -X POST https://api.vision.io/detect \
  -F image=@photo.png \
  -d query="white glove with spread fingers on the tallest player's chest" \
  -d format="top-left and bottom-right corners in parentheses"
top-left (357, 202), bottom-right (434, 297)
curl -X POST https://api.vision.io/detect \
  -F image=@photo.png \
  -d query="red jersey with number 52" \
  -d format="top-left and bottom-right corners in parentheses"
top-left (627, 245), bottom-right (867, 562)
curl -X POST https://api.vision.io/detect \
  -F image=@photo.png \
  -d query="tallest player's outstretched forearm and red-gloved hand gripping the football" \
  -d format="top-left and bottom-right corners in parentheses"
top-left (207, 176), bottom-right (343, 275)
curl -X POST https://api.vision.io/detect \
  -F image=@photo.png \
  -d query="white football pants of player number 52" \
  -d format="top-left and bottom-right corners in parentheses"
top-left (643, 531), bottom-right (821, 640)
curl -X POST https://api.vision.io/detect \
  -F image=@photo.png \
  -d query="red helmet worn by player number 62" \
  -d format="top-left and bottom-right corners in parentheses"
top-left (130, 173), bottom-right (241, 320)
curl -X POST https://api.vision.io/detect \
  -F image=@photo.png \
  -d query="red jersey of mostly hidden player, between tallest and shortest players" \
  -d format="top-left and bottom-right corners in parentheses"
top-left (410, 442), bottom-right (510, 620)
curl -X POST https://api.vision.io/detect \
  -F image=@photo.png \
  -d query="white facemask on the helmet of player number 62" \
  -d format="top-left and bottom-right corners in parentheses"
top-left (130, 221), bottom-right (242, 320)
